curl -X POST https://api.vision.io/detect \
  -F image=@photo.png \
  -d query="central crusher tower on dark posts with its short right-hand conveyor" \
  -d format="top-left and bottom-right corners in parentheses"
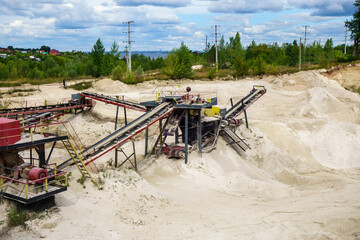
top-left (144, 86), bottom-right (266, 163)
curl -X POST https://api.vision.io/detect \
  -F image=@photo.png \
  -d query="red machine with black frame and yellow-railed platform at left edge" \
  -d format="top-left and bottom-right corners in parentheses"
top-left (0, 118), bottom-right (68, 204)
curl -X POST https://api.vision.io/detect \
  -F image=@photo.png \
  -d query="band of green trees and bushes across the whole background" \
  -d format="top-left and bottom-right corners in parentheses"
top-left (0, 33), bottom-right (356, 83)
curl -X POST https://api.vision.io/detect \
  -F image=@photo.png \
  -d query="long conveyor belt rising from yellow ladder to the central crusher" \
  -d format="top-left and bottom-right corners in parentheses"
top-left (58, 102), bottom-right (174, 169)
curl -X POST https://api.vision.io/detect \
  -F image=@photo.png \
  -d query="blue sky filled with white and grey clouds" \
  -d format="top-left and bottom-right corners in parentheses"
top-left (0, 0), bottom-right (355, 51)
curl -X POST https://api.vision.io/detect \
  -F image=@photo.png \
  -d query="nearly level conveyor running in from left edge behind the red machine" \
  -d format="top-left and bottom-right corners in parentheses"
top-left (0, 101), bottom-right (87, 117)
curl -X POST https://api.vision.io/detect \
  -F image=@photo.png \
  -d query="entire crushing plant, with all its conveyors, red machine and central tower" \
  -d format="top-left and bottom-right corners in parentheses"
top-left (0, 86), bottom-right (266, 204)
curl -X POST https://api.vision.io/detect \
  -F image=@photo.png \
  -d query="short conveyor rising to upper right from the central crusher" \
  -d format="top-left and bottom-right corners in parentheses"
top-left (224, 86), bottom-right (266, 120)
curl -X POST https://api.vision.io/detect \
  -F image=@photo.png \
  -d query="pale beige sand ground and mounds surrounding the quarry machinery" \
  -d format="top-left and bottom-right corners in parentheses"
top-left (0, 68), bottom-right (360, 240)
